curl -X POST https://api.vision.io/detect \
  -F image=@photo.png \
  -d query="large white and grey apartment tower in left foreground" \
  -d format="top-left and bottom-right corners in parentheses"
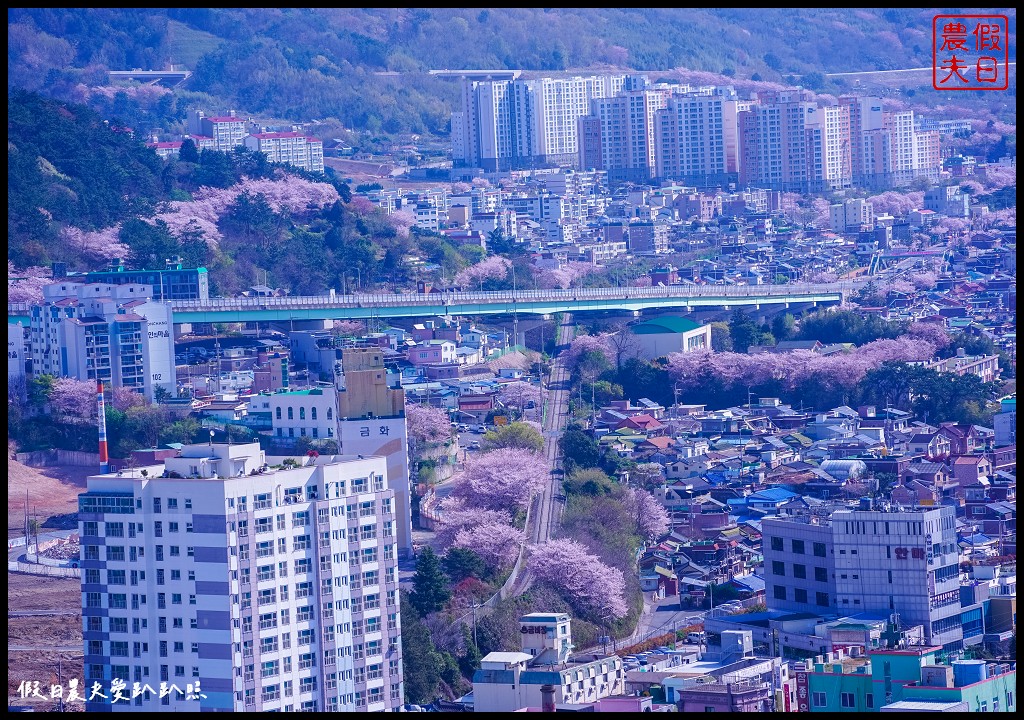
top-left (79, 443), bottom-right (402, 712)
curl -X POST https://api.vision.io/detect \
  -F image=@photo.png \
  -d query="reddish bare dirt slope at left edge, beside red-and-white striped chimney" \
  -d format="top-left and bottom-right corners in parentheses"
top-left (7, 458), bottom-right (90, 537)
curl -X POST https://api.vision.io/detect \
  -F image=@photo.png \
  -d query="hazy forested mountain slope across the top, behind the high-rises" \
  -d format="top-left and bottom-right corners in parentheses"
top-left (7, 8), bottom-right (978, 139)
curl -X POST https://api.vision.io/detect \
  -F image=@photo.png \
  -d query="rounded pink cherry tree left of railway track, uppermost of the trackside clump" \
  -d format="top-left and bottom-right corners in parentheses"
top-left (453, 448), bottom-right (548, 512)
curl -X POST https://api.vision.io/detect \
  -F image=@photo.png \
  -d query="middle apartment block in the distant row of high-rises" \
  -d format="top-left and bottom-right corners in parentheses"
top-left (654, 87), bottom-right (748, 185)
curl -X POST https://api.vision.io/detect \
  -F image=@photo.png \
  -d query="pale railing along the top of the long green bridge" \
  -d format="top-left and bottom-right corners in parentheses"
top-left (165, 282), bottom-right (860, 310)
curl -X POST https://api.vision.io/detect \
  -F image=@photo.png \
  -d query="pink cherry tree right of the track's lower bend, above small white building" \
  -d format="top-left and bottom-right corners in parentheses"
top-left (527, 539), bottom-right (629, 618)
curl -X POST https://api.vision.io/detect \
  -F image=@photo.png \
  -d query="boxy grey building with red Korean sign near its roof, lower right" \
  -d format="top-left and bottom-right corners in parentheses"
top-left (762, 507), bottom-right (964, 650)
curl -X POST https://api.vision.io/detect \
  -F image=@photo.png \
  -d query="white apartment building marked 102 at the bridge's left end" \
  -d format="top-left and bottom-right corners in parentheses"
top-left (30, 281), bottom-right (177, 400)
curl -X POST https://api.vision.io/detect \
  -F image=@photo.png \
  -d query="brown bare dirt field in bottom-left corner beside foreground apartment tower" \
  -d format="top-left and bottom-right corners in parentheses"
top-left (7, 573), bottom-right (84, 711)
